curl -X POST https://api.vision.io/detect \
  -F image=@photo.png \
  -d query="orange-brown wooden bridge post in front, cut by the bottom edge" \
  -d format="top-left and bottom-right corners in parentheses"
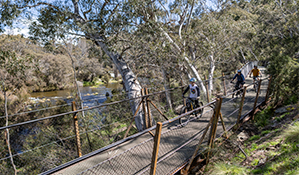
top-left (150, 122), bottom-right (162, 175)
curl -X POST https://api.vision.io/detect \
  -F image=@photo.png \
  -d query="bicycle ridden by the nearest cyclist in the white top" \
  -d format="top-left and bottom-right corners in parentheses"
top-left (179, 97), bottom-right (203, 126)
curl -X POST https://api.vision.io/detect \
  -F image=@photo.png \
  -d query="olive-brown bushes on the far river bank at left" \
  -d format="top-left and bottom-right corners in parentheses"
top-left (0, 34), bottom-right (102, 92)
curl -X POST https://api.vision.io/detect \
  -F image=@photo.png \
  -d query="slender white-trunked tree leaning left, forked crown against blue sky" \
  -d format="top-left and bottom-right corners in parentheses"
top-left (129, 0), bottom-right (206, 92)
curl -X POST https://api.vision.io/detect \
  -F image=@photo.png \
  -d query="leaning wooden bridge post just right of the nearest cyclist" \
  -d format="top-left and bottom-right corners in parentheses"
top-left (207, 98), bottom-right (223, 164)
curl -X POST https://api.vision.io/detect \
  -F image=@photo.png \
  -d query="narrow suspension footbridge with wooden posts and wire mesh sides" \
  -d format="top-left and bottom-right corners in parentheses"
top-left (0, 62), bottom-right (270, 175)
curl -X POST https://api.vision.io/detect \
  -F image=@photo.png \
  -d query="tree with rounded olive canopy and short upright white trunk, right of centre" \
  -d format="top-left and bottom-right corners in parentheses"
top-left (188, 7), bottom-right (255, 91)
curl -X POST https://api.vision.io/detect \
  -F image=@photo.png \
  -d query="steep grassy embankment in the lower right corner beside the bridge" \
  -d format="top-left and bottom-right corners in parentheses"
top-left (203, 102), bottom-right (299, 174)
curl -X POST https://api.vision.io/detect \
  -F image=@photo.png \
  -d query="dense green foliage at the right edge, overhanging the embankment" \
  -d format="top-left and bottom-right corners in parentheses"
top-left (243, 0), bottom-right (299, 103)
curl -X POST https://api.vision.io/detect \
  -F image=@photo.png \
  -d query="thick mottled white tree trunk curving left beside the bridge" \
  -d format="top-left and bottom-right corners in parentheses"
top-left (96, 41), bottom-right (145, 131)
